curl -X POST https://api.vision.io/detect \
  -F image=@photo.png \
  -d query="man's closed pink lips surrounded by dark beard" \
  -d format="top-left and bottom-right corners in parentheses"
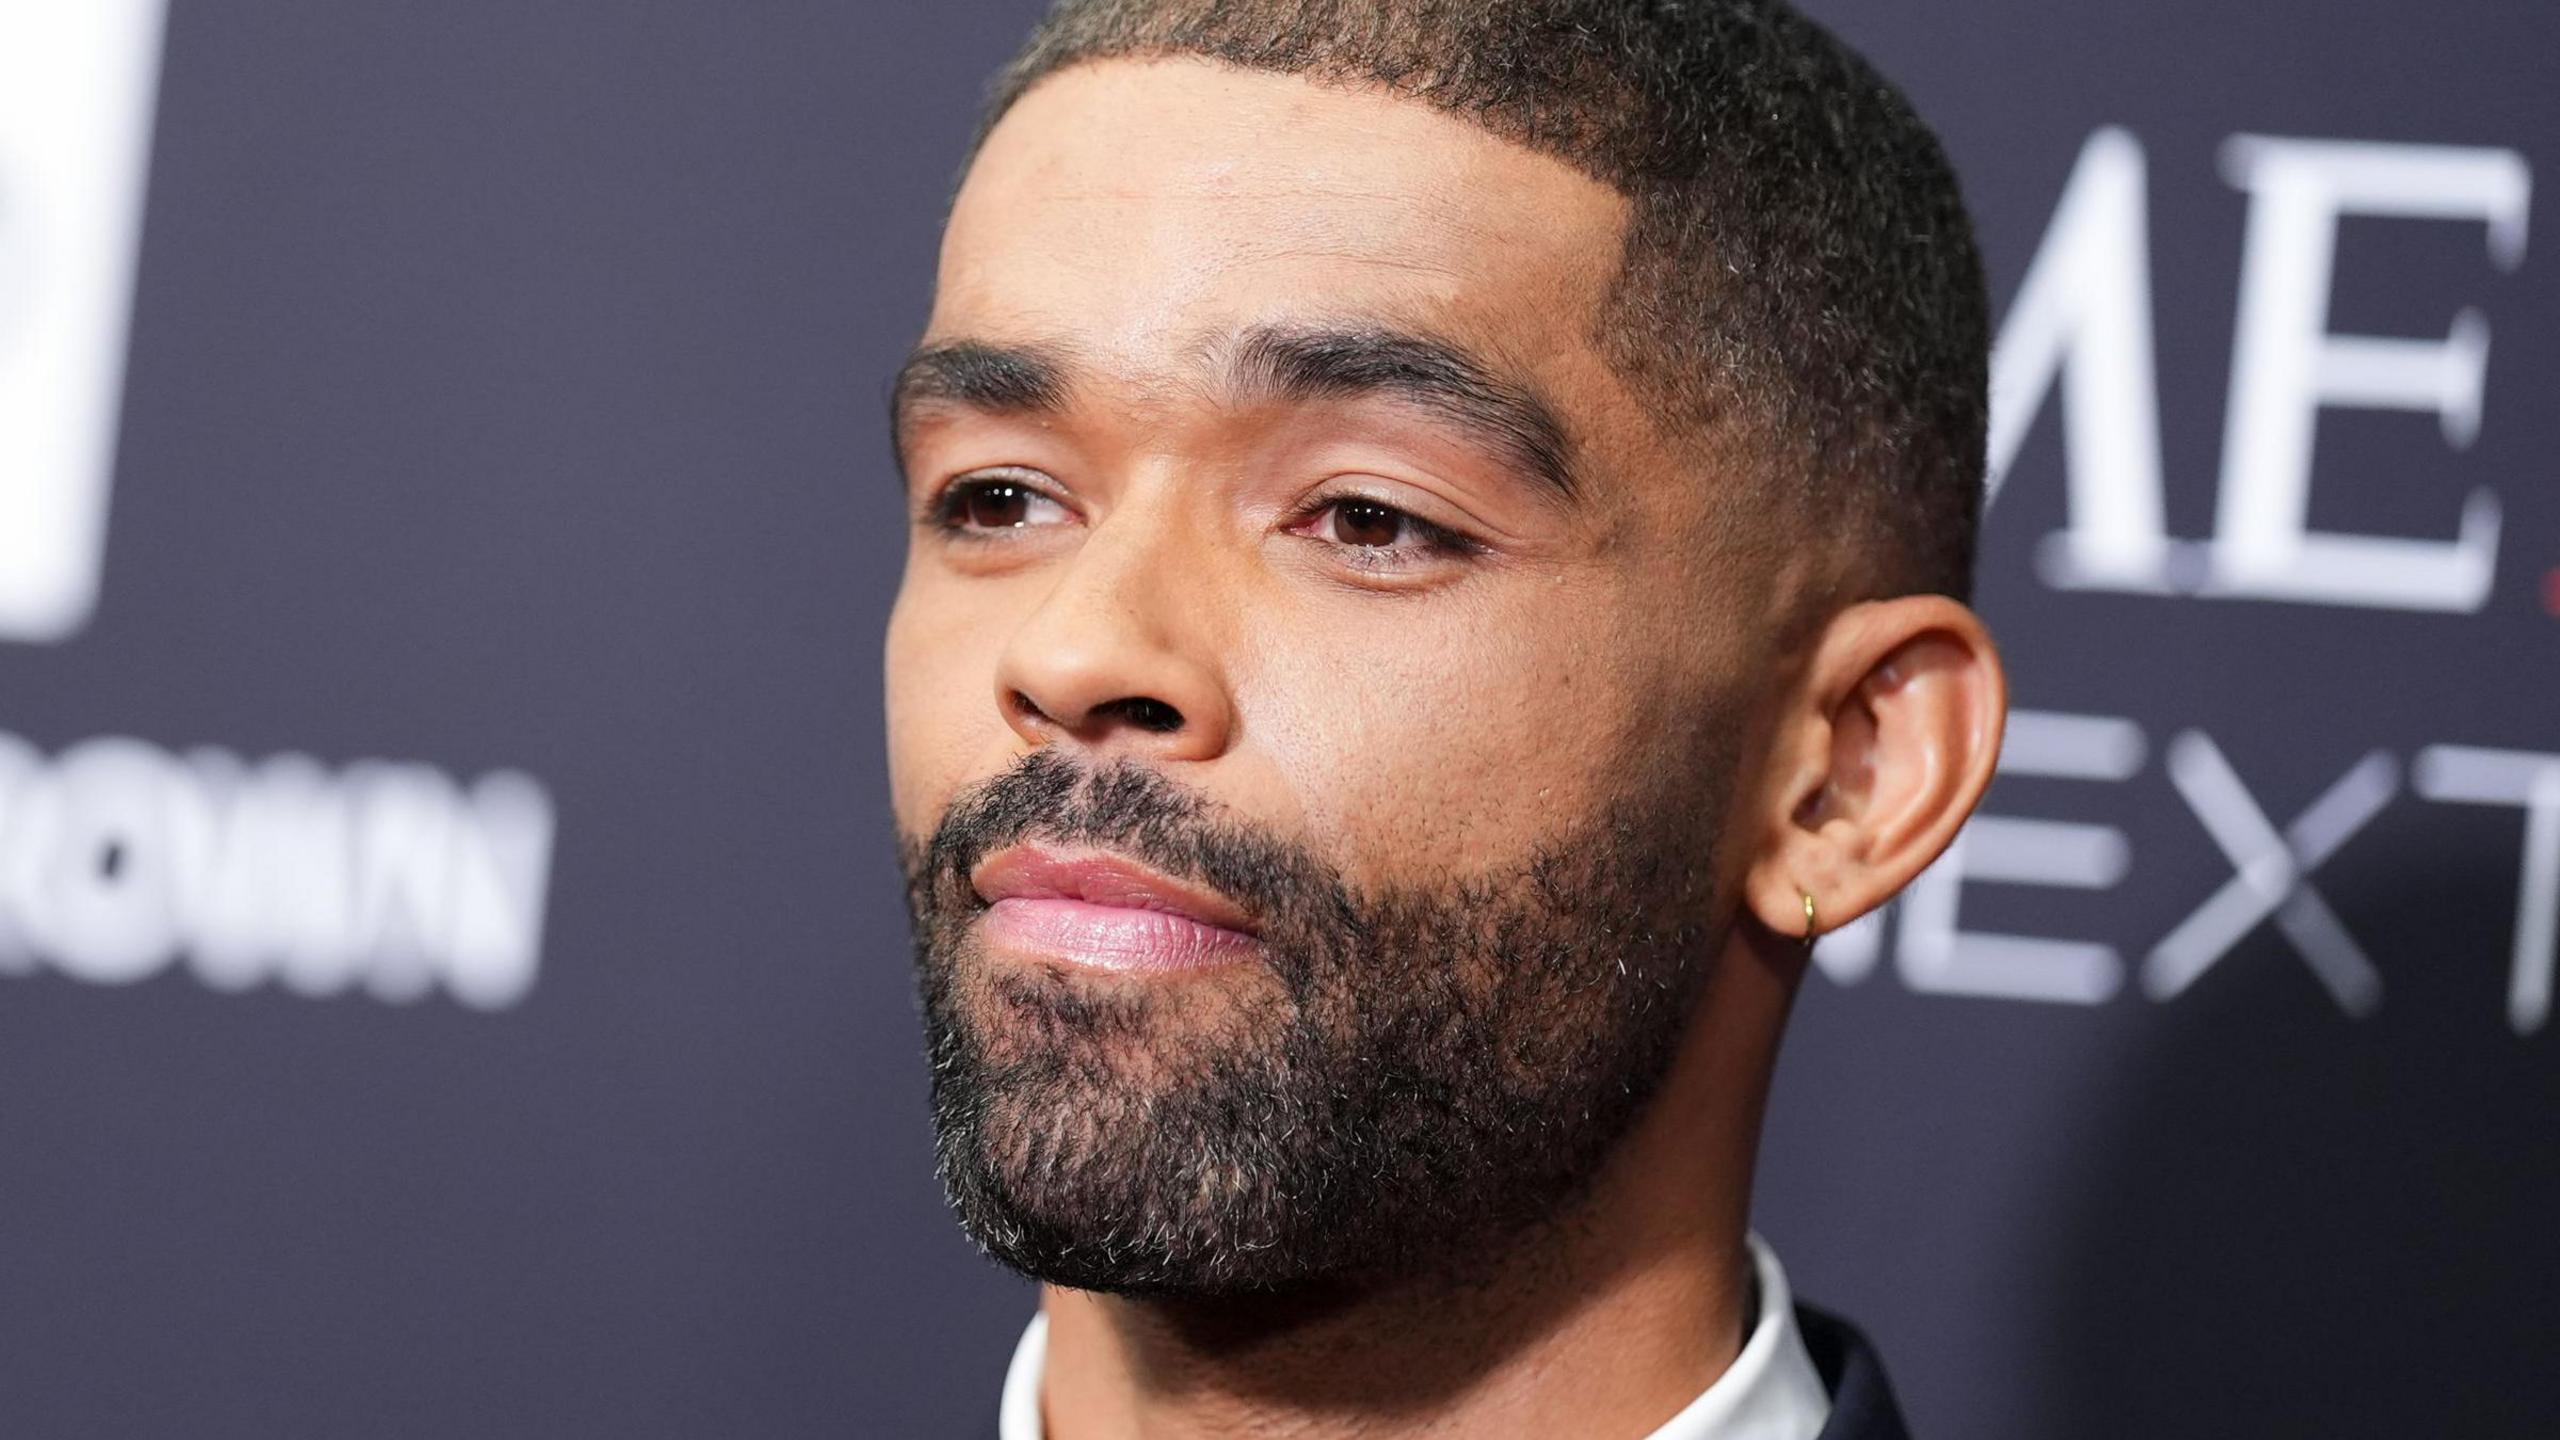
top-left (970, 846), bottom-right (1254, 974)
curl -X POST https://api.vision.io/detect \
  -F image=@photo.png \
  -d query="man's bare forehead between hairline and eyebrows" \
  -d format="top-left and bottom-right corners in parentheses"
top-left (929, 59), bottom-right (1626, 387)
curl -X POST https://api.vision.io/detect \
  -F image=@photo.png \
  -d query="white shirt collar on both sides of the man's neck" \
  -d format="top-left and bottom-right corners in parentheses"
top-left (996, 1235), bottom-right (1830, 1440)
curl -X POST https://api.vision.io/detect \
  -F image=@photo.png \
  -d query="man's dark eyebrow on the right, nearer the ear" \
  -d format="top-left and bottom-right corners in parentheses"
top-left (1231, 325), bottom-right (1580, 500)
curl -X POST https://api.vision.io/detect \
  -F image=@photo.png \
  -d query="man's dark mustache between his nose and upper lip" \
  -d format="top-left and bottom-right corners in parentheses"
top-left (904, 748), bottom-right (1357, 925)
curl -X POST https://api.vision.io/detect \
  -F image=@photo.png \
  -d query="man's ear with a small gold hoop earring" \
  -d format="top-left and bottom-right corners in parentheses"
top-left (1743, 594), bottom-right (2010, 938)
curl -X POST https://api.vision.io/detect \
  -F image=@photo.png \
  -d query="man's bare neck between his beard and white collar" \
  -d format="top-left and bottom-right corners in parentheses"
top-left (1042, 922), bottom-right (1797, 1440)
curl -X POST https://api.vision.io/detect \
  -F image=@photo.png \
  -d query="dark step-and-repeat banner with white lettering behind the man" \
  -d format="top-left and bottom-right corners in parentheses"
top-left (0, 0), bottom-right (2560, 1440)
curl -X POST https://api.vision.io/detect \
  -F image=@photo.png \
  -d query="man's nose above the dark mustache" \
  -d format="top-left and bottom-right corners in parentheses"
top-left (996, 512), bottom-right (1234, 761)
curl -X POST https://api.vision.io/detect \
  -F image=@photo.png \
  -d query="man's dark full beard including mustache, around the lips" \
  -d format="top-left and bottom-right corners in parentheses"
top-left (906, 751), bottom-right (1720, 1297)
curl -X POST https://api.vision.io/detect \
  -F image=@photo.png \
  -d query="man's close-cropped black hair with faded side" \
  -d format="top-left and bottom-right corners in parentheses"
top-left (978, 0), bottom-right (1989, 600)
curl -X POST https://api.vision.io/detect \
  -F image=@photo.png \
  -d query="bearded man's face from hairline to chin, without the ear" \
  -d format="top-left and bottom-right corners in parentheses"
top-left (886, 61), bottom-right (1772, 1291)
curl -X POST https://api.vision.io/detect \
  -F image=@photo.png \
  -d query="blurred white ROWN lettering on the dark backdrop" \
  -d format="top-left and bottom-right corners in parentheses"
top-left (0, 733), bottom-right (550, 1010)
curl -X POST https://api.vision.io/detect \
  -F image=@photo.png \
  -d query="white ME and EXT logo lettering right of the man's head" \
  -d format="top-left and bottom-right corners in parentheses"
top-left (1820, 128), bottom-right (2560, 1035)
